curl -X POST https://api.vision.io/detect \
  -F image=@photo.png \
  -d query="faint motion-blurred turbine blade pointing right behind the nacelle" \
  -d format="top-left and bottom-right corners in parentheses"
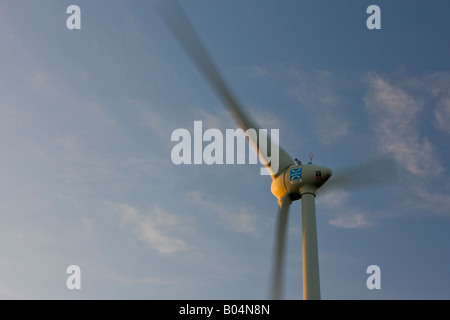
top-left (319, 157), bottom-right (398, 193)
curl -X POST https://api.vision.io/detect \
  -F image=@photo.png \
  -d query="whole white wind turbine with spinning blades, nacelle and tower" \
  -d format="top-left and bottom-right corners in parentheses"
top-left (158, 0), bottom-right (395, 300)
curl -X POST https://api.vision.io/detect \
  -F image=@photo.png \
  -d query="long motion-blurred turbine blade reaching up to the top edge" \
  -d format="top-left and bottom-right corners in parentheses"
top-left (158, 0), bottom-right (294, 178)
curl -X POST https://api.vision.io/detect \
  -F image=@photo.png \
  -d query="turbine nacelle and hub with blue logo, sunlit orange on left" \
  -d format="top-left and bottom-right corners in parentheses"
top-left (271, 164), bottom-right (332, 201)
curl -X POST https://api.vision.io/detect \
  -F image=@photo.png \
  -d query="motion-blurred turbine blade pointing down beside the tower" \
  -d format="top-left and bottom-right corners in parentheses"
top-left (271, 196), bottom-right (291, 300)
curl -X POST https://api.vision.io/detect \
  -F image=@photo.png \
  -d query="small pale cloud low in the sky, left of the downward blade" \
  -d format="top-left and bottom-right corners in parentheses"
top-left (113, 204), bottom-right (187, 254)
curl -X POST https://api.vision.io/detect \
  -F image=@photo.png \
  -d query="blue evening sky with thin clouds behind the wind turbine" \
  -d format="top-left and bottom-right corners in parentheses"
top-left (0, 0), bottom-right (450, 300)
